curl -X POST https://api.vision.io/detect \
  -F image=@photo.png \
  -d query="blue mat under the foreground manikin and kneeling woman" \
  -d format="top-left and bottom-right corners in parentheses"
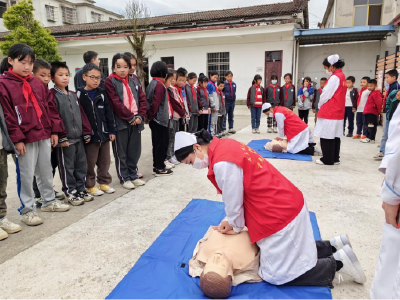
top-left (106, 199), bottom-right (332, 299)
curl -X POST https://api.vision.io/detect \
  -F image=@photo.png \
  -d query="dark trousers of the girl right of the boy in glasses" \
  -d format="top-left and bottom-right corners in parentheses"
top-left (113, 125), bottom-right (142, 184)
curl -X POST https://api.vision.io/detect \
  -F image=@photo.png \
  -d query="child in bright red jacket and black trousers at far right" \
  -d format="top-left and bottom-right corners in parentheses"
top-left (361, 79), bottom-right (382, 144)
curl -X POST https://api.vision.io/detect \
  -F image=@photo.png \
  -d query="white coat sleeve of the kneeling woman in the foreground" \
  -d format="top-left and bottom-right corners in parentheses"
top-left (214, 161), bottom-right (246, 232)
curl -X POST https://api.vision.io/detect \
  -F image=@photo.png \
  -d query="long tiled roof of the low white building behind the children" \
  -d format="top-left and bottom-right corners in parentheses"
top-left (48, 0), bottom-right (308, 35)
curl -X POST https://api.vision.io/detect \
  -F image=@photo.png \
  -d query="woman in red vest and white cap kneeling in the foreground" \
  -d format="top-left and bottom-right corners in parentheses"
top-left (175, 130), bottom-right (366, 286)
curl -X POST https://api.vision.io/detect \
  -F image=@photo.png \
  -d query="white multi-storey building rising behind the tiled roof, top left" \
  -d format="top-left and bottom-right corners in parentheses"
top-left (0, 0), bottom-right (123, 31)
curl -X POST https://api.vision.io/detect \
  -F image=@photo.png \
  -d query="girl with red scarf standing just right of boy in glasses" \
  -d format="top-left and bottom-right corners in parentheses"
top-left (104, 53), bottom-right (146, 186)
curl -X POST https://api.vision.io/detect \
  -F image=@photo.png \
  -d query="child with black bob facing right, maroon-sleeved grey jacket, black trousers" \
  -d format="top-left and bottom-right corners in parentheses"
top-left (146, 61), bottom-right (173, 177)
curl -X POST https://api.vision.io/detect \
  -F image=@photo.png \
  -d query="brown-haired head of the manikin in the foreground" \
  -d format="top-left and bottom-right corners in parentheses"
top-left (200, 252), bottom-right (233, 299)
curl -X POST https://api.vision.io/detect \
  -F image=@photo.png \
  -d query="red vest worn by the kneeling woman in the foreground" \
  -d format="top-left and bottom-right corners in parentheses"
top-left (207, 138), bottom-right (304, 243)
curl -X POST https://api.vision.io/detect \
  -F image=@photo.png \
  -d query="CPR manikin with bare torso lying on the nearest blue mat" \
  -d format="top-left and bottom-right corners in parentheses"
top-left (189, 219), bottom-right (262, 299)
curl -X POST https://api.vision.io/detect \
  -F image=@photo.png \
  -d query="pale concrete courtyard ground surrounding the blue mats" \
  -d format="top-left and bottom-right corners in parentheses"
top-left (0, 106), bottom-right (384, 298)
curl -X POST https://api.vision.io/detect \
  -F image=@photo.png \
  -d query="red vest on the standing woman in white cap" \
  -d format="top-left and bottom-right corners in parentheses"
top-left (318, 69), bottom-right (347, 120)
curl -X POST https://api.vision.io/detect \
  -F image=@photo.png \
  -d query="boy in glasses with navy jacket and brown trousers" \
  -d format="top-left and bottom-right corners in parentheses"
top-left (77, 63), bottom-right (116, 196)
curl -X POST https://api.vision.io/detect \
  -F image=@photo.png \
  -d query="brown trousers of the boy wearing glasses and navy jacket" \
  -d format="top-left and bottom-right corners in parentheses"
top-left (85, 141), bottom-right (112, 189)
